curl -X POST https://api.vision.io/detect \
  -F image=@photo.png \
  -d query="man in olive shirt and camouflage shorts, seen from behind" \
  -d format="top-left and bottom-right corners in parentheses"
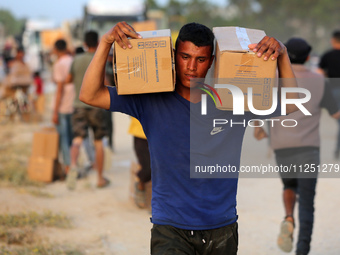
top-left (66, 31), bottom-right (110, 190)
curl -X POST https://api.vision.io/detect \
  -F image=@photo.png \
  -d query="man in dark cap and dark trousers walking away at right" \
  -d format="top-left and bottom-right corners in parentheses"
top-left (254, 37), bottom-right (340, 255)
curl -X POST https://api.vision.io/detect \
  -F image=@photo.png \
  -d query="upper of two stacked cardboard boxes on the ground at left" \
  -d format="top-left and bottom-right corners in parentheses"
top-left (32, 127), bottom-right (59, 159)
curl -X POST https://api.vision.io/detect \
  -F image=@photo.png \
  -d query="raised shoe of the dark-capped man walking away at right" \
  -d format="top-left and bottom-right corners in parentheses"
top-left (277, 215), bottom-right (294, 252)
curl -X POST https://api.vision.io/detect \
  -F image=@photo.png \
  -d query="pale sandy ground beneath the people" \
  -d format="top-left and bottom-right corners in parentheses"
top-left (0, 91), bottom-right (340, 255)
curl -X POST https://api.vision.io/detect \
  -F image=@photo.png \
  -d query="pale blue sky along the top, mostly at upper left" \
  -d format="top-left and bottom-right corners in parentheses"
top-left (0, 0), bottom-right (225, 24)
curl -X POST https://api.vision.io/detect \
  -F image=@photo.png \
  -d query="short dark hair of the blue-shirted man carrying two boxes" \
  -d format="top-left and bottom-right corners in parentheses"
top-left (176, 22), bottom-right (215, 54)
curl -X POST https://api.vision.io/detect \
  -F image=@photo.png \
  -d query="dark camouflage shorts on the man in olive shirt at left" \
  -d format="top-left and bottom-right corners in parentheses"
top-left (72, 108), bottom-right (108, 140)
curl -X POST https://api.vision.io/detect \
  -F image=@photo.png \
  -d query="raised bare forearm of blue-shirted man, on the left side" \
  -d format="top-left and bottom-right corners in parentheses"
top-left (79, 41), bottom-right (111, 109)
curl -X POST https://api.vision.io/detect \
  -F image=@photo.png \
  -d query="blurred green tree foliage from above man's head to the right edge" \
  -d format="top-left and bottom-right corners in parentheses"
top-left (164, 0), bottom-right (340, 53)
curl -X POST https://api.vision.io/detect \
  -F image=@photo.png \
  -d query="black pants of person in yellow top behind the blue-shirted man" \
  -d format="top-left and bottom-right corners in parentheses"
top-left (134, 137), bottom-right (151, 183)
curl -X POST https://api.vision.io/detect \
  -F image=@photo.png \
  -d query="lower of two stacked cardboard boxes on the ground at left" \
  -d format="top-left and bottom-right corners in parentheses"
top-left (27, 157), bottom-right (61, 183)
